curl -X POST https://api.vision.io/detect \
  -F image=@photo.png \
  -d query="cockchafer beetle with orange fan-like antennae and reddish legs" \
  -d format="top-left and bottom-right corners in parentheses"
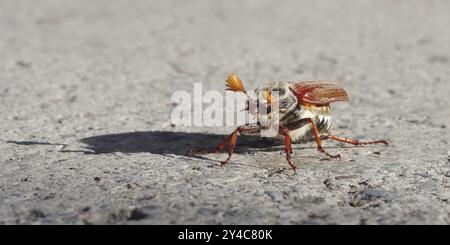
top-left (190, 73), bottom-right (389, 172)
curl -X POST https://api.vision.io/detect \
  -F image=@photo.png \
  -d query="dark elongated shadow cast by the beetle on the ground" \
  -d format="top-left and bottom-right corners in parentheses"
top-left (74, 131), bottom-right (282, 155)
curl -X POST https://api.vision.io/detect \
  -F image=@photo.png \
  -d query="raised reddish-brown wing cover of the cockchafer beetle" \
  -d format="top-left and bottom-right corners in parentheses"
top-left (291, 81), bottom-right (348, 105)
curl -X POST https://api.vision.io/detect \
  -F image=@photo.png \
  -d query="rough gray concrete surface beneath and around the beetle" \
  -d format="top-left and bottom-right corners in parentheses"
top-left (0, 0), bottom-right (450, 224)
